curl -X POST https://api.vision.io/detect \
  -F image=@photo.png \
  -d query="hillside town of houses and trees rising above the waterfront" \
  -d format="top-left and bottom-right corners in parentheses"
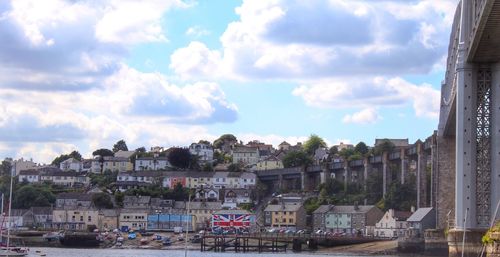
top-left (0, 135), bottom-right (436, 244)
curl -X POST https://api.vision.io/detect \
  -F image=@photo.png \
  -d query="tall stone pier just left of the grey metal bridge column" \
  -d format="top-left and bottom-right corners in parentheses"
top-left (436, 136), bottom-right (455, 229)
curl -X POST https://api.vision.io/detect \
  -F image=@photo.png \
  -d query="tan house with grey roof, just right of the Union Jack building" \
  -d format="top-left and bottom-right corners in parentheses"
top-left (264, 203), bottom-right (306, 230)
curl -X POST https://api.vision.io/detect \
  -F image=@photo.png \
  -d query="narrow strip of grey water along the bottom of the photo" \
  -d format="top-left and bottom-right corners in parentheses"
top-left (28, 248), bottom-right (406, 257)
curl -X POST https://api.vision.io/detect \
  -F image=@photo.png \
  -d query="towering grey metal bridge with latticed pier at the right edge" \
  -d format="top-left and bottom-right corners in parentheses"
top-left (436, 0), bottom-right (500, 256)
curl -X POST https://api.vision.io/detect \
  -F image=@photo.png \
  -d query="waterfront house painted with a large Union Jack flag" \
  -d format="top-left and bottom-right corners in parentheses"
top-left (211, 210), bottom-right (256, 229)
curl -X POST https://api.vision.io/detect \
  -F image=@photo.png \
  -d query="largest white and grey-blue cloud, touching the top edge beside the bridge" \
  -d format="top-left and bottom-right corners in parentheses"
top-left (170, 0), bottom-right (456, 79)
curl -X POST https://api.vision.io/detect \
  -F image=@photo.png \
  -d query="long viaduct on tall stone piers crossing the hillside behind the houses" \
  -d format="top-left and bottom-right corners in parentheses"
top-left (256, 134), bottom-right (437, 207)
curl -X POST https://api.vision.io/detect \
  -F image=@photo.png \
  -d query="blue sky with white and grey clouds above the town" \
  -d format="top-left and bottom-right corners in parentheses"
top-left (0, 0), bottom-right (458, 163)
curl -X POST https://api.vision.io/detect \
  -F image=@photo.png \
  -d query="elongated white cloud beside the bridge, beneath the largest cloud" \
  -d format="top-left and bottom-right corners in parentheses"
top-left (292, 77), bottom-right (440, 121)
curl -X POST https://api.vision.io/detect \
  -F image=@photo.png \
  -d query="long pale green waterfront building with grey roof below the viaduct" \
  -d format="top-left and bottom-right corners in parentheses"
top-left (313, 205), bottom-right (384, 235)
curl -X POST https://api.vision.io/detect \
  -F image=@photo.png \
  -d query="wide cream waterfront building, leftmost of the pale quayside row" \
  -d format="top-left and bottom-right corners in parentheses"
top-left (52, 206), bottom-right (99, 231)
